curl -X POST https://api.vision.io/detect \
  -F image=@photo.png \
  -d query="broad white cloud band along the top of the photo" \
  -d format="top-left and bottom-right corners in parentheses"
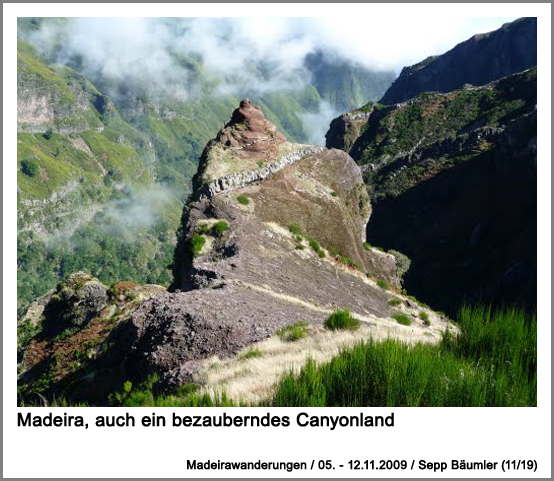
top-left (20, 15), bottom-right (511, 99)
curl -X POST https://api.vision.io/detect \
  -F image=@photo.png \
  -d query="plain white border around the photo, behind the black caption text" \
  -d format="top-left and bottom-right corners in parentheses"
top-left (3, 4), bottom-right (551, 477)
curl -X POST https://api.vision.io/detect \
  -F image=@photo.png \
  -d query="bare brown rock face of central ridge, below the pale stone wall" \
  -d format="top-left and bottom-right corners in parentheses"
top-left (121, 106), bottom-right (404, 389)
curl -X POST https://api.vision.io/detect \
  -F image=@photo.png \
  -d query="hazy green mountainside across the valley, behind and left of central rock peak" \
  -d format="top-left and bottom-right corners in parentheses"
top-left (17, 30), bottom-right (386, 316)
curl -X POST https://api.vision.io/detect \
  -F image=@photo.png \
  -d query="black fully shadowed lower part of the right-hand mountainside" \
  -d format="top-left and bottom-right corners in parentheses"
top-left (368, 109), bottom-right (537, 316)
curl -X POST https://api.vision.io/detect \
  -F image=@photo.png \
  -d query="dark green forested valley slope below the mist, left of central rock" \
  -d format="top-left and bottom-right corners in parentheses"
top-left (17, 214), bottom-right (175, 317)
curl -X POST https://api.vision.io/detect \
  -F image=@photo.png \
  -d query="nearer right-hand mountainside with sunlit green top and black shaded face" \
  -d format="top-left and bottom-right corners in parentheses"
top-left (327, 68), bottom-right (537, 314)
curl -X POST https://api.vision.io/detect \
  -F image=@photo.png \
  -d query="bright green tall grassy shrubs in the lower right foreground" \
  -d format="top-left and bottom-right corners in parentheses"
top-left (268, 308), bottom-right (537, 406)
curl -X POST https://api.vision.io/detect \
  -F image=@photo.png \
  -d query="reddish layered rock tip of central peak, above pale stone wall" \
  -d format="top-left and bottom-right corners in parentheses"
top-left (216, 99), bottom-right (286, 158)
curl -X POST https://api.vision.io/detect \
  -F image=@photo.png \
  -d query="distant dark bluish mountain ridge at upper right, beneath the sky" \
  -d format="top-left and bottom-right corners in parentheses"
top-left (379, 17), bottom-right (537, 105)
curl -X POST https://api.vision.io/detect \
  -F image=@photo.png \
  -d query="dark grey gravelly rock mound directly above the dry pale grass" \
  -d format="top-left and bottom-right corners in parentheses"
top-left (122, 285), bottom-right (325, 390)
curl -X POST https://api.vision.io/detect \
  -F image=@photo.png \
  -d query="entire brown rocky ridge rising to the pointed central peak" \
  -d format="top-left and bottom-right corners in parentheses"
top-left (20, 99), bottom-right (448, 403)
